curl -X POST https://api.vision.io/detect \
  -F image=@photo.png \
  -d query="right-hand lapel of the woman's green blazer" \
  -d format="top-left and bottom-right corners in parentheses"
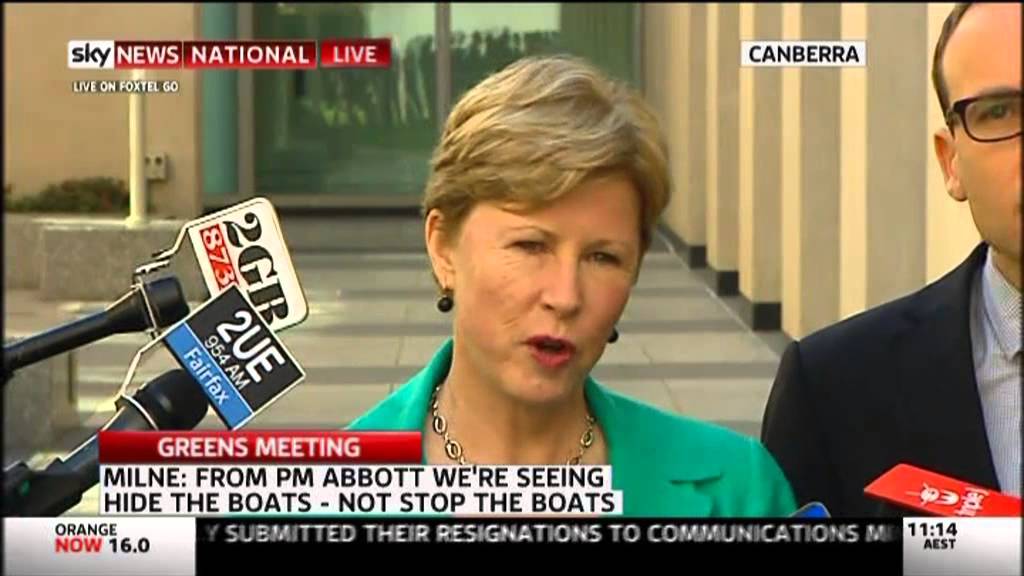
top-left (586, 378), bottom-right (722, 518)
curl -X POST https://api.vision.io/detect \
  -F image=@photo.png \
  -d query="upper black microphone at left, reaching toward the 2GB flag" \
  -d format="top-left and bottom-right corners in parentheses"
top-left (3, 277), bottom-right (188, 383)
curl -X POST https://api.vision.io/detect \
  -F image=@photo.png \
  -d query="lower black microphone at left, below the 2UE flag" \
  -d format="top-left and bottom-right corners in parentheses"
top-left (3, 370), bottom-right (209, 517)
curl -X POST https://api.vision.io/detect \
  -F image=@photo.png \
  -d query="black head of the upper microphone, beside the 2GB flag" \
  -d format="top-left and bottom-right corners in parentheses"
top-left (106, 276), bottom-right (188, 334)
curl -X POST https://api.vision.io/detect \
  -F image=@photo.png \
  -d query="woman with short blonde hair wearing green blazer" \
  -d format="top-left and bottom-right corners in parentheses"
top-left (350, 56), bottom-right (795, 516)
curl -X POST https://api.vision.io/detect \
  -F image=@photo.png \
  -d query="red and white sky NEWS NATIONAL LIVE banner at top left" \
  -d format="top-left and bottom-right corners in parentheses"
top-left (68, 38), bottom-right (391, 70)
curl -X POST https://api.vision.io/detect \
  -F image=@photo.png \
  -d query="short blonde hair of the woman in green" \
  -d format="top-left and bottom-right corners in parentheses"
top-left (423, 55), bottom-right (670, 260)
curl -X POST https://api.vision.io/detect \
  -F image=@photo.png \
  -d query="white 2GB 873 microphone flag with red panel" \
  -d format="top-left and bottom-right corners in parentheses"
top-left (184, 198), bottom-right (309, 332)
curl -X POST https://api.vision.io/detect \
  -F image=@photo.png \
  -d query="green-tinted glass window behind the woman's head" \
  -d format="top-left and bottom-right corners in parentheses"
top-left (244, 3), bottom-right (638, 206)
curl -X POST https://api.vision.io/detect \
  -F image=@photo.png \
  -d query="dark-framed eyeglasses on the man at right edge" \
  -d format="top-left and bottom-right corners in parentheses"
top-left (946, 90), bottom-right (1024, 142)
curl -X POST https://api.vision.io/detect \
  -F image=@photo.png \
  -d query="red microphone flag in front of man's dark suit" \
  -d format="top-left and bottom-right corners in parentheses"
top-left (864, 464), bottom-right (1021, 517)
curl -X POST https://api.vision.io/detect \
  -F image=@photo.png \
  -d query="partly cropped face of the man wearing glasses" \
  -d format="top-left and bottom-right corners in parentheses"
top-left (935, 4), bottom-right (1021, 284)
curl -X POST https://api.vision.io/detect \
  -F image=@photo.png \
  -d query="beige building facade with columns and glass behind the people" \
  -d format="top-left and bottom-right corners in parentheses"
top-left (4, 3), bottom-right (978, 337)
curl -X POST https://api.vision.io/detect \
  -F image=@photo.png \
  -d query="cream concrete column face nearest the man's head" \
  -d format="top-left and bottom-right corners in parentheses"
top-left (866, 4), bottom-right (930, 306)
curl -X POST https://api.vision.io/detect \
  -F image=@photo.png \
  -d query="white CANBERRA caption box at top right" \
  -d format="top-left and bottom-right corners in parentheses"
top-left (740, 40), bottom-right (867, 68)
